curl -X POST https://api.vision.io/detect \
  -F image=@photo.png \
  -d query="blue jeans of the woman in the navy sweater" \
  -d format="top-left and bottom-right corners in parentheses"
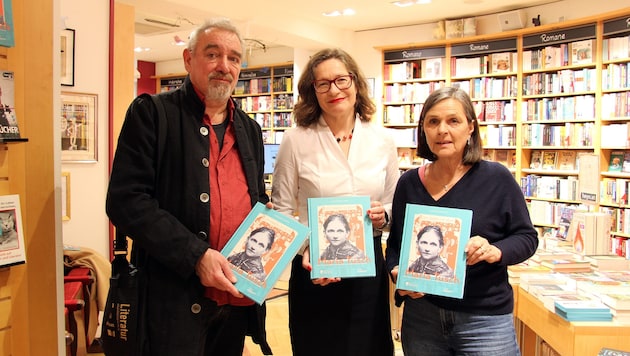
top-left (401, 298), bottom-right (521, 356)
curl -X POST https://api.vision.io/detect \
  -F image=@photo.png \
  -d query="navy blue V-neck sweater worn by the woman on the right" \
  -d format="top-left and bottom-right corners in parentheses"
top-left (386, 161), bottom-right (538, 315)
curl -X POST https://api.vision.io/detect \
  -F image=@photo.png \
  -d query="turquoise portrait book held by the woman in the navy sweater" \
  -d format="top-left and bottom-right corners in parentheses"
top-left (396, 204), bottom-right (472, 299)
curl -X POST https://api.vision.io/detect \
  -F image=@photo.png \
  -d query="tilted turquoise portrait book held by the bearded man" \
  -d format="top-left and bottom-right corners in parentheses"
top-left (221, 203), bottom-right (309, 304)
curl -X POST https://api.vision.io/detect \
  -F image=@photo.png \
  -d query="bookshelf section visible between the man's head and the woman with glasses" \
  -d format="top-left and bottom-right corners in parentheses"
top-left (232, 64), bottom-right (294, 143)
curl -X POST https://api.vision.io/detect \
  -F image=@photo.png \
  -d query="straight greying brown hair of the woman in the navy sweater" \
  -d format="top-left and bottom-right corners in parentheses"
top-left (416, 87), bottom-right (483, 165)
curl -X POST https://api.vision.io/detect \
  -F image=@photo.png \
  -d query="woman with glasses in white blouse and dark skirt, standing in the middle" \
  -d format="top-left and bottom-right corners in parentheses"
top-left (272, 49), bottom-right (400, 356)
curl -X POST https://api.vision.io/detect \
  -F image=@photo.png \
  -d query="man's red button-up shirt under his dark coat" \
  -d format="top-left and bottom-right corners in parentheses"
top-left (204, 95), bottom-right (254, 306)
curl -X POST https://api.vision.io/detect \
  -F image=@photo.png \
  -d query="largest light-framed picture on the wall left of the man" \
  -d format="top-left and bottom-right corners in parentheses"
top-left (60, 92), bottom-right (98, 163)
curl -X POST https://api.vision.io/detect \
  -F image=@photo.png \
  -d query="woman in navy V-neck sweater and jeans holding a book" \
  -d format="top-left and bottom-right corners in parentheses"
top-left (386, 88), bottom-right (538, 356)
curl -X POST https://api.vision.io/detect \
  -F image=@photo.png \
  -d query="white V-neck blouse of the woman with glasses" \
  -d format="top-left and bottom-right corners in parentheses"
top-left (271, 115), bottom-right (400, 225)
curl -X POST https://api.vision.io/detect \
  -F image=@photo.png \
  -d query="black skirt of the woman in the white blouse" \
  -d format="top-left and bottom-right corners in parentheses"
top-left (289, 238), bottom-right (394, 356)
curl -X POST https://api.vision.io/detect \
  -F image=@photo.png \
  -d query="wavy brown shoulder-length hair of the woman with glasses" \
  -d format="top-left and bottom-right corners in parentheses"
top-left (293, 48), bottom-right (376, 127)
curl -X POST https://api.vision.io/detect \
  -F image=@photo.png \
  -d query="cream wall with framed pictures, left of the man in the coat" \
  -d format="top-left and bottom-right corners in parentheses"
top-left (60, 0), bottom-right (109, 256)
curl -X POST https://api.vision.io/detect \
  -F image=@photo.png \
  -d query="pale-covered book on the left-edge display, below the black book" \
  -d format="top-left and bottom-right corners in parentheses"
top-left (0, 194), bottom-right (26, 267)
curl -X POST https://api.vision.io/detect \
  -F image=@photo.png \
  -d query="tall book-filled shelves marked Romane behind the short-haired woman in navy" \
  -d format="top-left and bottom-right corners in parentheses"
top-left (380, 8), bottom-right (630, 257)
